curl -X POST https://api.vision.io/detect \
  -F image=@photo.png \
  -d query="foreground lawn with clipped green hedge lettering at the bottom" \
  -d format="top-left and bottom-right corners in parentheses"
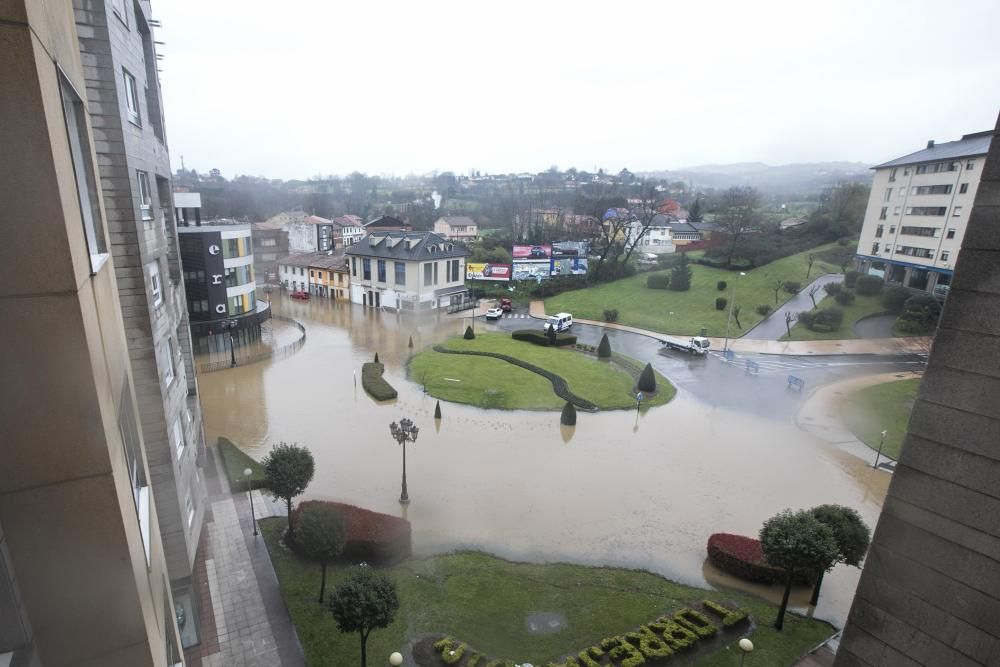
top-left (261, 518), bottom-right (832, 667)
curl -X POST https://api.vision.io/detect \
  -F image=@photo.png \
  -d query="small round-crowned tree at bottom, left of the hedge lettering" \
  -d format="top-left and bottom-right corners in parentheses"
top-left (330, 565), bottom-right (399, 667)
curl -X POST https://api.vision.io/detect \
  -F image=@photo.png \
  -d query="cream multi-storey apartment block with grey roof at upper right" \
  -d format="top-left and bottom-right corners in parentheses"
top-left (857, 131), bottom-right (992, 296)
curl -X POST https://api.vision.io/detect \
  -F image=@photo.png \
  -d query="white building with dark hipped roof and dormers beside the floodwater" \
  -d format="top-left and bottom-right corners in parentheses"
top-left (345, 232), bottom-right (469, 311)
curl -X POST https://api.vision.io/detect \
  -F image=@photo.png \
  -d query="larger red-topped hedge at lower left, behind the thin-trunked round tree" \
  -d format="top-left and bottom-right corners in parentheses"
top-left (292, 500), bottom-right (411, 565)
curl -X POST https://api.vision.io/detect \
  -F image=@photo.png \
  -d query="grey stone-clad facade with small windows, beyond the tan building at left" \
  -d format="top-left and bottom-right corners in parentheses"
top-left (74, 0), bottom-right (206, 585)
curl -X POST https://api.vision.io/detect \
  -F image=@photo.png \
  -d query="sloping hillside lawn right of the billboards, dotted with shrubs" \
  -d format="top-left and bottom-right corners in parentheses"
top-left (545, 243), bottom-right (840, 336)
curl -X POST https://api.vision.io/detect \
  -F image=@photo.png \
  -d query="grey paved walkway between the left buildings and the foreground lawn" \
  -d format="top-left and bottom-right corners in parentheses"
top-left (184, 447), bottom-right (305, 667)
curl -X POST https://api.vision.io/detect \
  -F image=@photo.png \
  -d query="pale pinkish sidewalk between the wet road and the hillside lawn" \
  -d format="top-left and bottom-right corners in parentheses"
top-left (530, 301), bottom-right (932, 356)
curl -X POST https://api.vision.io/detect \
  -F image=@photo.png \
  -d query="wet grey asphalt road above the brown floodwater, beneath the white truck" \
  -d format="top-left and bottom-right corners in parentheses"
top-left (476, 310), bottom-right (926, 421)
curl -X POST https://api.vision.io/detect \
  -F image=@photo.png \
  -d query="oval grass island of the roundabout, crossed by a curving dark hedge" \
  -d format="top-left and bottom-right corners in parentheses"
top-left (409, 333), bottom-right (677, 410)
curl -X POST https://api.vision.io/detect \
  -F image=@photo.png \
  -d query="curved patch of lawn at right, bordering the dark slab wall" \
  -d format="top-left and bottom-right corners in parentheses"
top-left (843, 378), bottom-right (920, 459)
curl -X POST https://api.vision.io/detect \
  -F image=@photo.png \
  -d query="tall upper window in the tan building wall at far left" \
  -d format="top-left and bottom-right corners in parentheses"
top-left (59, 72), bottom-right (108, 274)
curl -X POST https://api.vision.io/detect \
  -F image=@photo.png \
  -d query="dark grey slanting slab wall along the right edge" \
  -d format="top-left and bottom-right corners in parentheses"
top-left (836, 118), bottom-right (1000, 667)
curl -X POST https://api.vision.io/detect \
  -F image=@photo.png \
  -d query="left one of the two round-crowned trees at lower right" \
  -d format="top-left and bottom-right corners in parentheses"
top-left (760, 510), bottom-right (839, 630)
